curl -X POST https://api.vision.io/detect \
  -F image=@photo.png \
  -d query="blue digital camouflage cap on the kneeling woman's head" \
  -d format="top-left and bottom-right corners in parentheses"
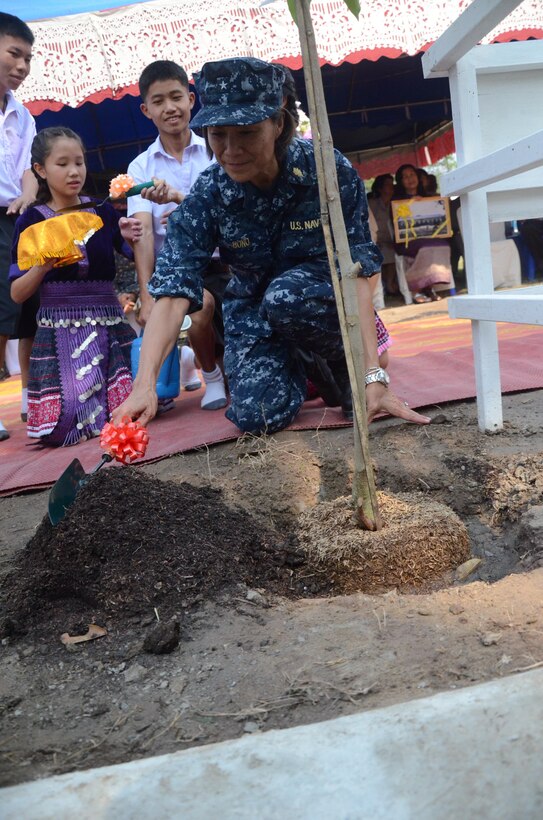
top-left (190, 57), bottom-right (285, 128)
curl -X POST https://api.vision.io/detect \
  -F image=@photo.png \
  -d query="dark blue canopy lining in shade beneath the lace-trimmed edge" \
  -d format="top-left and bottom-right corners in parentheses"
top-left (36, 55), bottom-right (454, 177)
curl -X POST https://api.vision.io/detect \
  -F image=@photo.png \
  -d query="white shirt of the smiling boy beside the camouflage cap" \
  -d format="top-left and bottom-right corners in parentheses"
top-left (127, 131), bottom-right (214, 255)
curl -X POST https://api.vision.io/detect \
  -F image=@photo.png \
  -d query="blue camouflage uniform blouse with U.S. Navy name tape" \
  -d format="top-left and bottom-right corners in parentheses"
top-left (149, 140), bottom-right (382, 312)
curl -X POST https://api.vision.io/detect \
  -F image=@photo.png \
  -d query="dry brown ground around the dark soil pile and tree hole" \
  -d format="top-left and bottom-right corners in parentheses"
top-left (0, 382), bottom-right (543, 785)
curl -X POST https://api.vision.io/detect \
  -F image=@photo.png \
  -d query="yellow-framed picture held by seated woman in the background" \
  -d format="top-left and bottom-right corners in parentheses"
top-left (391, 196), bottom-right (452, 244)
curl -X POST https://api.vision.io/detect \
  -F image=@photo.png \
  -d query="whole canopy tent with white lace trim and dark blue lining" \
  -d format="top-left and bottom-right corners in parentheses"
top-left (8, 0), bottom-right (543, 181)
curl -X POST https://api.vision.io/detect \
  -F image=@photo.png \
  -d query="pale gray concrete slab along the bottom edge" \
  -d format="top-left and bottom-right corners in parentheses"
top-left (0, 669), bottom-right (543, 820)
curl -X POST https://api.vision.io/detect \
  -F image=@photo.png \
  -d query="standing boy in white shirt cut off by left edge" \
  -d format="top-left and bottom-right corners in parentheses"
top-left (0, 12), bottom-right (39, 441)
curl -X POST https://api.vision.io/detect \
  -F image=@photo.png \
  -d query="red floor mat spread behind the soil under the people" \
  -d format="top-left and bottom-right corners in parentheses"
top-left (0, 315), bottom-right (543, 495)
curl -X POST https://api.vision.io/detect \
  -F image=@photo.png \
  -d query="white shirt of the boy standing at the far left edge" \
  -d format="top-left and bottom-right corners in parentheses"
top-left (0, 91), bottom-right (36, 208)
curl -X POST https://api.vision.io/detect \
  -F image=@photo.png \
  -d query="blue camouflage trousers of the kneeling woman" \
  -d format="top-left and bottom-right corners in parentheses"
top-left (223, 263), bottom-right (343, 434)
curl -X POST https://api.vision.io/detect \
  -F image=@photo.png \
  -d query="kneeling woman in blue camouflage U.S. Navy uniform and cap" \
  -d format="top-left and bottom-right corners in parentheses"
top-left (114, 57), bottom-right (430, 434)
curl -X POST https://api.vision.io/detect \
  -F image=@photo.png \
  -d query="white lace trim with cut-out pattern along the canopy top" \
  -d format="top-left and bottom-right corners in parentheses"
top-left (18, 0), bottom-right (543, 109)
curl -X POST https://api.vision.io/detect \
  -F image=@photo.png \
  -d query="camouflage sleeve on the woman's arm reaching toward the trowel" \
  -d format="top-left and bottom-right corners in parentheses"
top-left (149, 172), bottom-right (217, 313)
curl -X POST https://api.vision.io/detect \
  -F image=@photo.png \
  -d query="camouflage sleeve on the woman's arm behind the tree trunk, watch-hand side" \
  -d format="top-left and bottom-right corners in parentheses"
top-left (336, 151), bottom-right (383, 277)
